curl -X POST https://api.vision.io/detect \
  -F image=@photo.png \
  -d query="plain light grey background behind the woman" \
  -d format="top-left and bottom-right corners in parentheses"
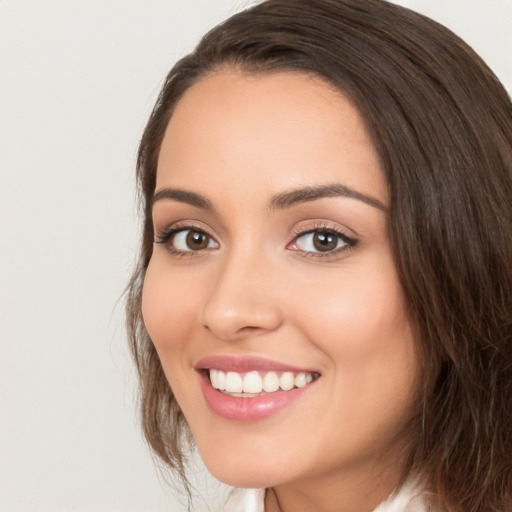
top-left (0, 0), bottom-right (512, 512)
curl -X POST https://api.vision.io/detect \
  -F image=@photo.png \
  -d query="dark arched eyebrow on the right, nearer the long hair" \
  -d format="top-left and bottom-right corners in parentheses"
top-left (270, 183), bottom-right (387, 211)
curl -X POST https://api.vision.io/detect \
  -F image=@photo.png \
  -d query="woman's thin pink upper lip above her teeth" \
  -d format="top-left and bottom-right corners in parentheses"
top-left (194, 355), bottom-right (314, 373)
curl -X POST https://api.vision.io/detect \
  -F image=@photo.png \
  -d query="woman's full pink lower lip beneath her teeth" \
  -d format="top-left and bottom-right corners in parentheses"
top-left (199, 372), bottom-right (311, 421)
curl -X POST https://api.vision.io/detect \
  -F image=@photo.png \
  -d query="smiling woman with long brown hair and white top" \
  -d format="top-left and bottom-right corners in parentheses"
top-left (127, 0), bottom-right (512, 512)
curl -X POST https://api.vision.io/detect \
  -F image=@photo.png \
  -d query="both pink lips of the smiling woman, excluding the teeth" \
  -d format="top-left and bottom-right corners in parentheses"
top-left (195, 356), bottom-right (316, 421)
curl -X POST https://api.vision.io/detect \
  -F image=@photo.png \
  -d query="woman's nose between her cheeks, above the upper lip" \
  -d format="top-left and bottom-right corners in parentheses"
top-left (202, 251), bottom-right (282, 341)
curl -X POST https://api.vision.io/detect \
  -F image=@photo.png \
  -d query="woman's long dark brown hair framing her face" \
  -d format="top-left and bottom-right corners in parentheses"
top-left (127, 0), bottom-right (512, 512)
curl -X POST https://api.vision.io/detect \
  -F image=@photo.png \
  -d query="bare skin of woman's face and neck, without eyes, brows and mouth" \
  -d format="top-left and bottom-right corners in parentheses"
top-left (142, 70), bottom-right (418, 512)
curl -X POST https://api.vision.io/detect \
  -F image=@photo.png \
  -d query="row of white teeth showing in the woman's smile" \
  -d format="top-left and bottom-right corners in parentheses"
top-left (208, 368), bottom-right (320, 397)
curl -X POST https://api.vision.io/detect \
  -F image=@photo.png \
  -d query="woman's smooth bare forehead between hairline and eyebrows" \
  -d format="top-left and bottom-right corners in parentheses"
top-left (157, 70), bottom-right (387, 206)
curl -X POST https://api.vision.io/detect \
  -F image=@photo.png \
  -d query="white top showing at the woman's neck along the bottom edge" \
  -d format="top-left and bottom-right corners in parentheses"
top-left (222, 484), bottom-right (427, 512)
